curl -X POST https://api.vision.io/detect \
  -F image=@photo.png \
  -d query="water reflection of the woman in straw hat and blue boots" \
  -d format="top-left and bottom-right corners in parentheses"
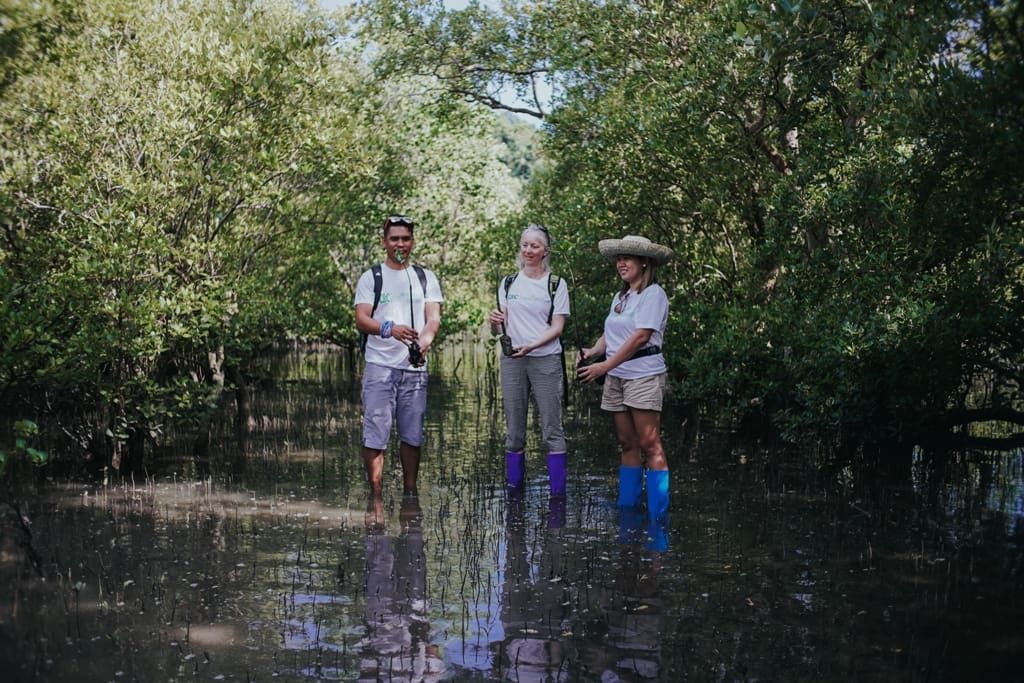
top-left (577, 509), bottom-right (668, 681)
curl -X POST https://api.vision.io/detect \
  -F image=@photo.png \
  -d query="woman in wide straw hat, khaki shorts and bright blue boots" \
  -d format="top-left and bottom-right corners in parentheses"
top-left (578, 234), bottom-right (672, 520)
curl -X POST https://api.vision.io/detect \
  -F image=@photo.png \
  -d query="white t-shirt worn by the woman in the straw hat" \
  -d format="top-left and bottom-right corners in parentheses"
top-left (604, 283), bottom-right (669, 380)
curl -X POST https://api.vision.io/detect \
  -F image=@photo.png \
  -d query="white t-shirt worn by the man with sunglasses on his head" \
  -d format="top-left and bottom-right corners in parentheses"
top-left (355, 263), bottom-right (444, 371)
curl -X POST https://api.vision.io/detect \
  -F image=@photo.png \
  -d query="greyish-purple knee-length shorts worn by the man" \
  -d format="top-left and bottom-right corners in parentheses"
top-left (362, 362), bottom-right (427, 451)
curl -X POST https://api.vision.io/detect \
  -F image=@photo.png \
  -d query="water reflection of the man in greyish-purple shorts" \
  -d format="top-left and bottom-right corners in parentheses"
top-left (359, 496), bottom-right (444, 681)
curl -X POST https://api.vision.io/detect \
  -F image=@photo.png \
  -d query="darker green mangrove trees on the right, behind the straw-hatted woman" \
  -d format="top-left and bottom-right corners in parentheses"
top-left (360, 0), bottom-right (1024, 448)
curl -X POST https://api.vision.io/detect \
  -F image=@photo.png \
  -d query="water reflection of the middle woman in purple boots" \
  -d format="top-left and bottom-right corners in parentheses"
top-left (496, 496), bottom-right (571, 683)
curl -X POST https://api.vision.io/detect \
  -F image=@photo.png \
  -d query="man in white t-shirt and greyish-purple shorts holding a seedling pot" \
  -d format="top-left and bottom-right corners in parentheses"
top-left (355, 216), bottom-right (444, 496)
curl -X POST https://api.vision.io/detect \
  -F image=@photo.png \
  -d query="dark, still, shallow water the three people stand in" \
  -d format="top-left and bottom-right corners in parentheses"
top-left (0, 349), bottom-right (1024, 681)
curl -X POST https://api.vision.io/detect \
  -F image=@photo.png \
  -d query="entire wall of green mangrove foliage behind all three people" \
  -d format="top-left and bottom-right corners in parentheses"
top-left (0, 0), bottom-right (1024, 471)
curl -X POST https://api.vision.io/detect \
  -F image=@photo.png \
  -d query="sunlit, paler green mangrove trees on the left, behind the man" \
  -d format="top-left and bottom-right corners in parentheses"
top-left (0, 0), bottom-right (522, 466)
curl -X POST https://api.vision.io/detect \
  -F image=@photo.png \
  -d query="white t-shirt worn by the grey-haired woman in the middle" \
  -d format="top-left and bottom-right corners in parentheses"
top-left (498, 270), bottom-right (569, 356)
